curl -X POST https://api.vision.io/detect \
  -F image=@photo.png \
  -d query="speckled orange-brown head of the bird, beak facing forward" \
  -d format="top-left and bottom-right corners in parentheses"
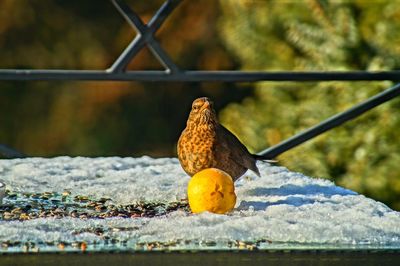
top-left (188, 97), bottom-right (217, 128)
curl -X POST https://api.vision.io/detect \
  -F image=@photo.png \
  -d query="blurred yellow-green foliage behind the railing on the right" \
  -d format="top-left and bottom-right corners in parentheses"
top-left (219, 0), bottom-right (400, 209)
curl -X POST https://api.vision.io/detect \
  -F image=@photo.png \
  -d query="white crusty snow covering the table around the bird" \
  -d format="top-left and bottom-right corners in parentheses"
top-left (0, 157), bottom-right (400, 251)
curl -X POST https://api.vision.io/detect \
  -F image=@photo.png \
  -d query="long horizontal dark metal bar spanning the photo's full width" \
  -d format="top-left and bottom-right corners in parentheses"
top-left (0, 69), bottom-right (400, 82)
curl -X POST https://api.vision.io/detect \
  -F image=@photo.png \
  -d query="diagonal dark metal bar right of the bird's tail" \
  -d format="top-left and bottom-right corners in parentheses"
top-left (259, 83), bottom-right (400, 158)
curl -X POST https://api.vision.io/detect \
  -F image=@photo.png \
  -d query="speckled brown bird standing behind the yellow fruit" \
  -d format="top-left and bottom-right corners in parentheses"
top-left (177, 97), bottom-right (275, 181)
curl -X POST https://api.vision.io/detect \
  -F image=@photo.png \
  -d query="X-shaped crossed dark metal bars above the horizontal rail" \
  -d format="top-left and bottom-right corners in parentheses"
top-left (108, 0), bottom-right (180, 72)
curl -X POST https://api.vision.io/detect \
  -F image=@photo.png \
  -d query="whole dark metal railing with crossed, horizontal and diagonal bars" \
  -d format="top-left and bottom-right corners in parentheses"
top-left (0, 0), bottom-right (400, 158)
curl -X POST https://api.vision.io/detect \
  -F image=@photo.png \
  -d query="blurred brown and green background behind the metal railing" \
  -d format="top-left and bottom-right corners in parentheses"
top-left (0, 0), bottom-right (400, 210)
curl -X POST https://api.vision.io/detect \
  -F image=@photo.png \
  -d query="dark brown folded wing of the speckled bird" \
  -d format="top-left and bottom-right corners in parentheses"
top-left (217, 125), bottom-right (259, 174)
